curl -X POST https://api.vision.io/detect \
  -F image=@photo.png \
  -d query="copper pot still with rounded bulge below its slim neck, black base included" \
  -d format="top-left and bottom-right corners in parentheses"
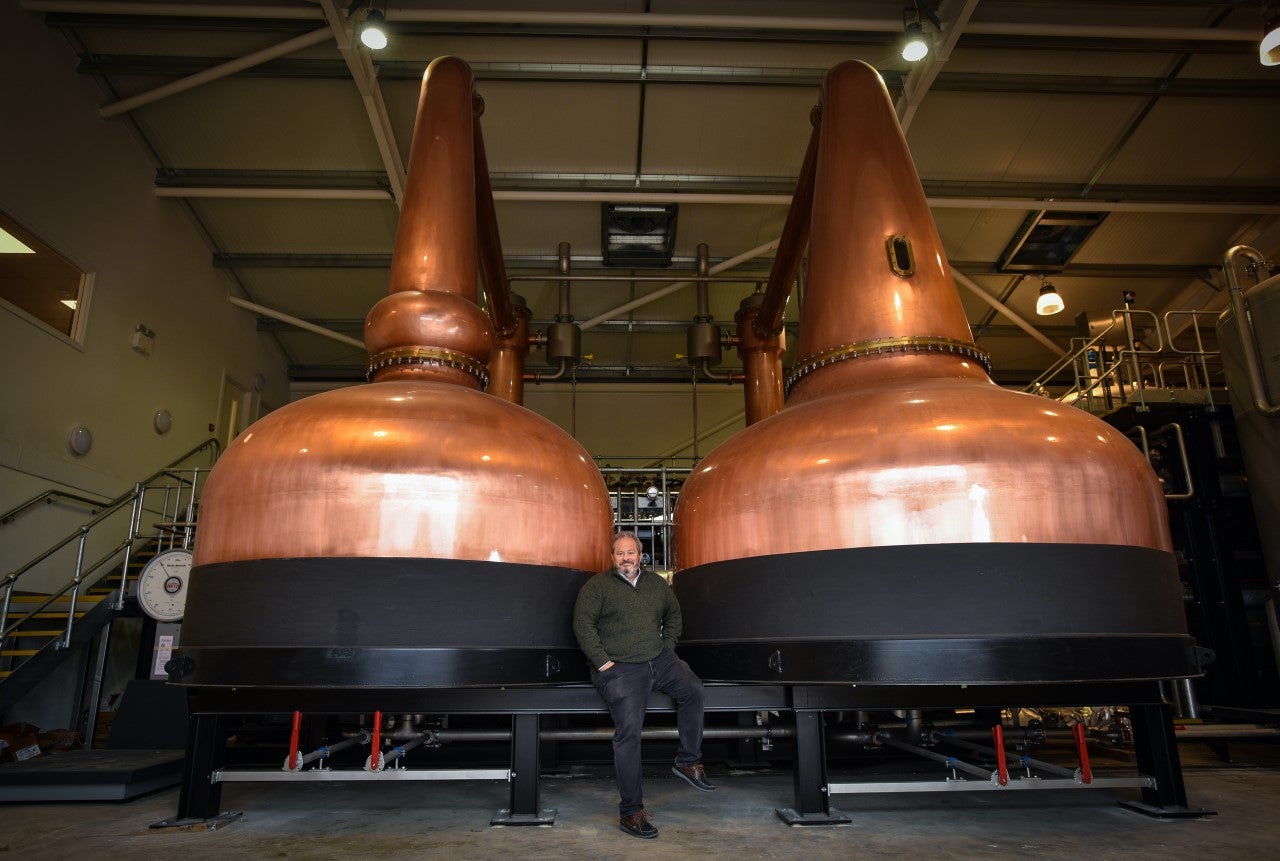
top-left (174, 58), bottom-right (612, 687)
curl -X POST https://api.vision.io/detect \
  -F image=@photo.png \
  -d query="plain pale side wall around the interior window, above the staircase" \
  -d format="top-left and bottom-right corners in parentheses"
top-left (0, 3), bottom-right (288, 587)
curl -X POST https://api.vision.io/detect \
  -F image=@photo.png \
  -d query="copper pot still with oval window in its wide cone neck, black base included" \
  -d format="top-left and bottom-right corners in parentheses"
top-left (675, 61), bottom-right (1198, 683)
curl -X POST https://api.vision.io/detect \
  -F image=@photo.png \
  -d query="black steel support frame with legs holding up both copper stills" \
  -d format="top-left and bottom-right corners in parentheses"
top-left (165, 682), bottom-right (1210, 826)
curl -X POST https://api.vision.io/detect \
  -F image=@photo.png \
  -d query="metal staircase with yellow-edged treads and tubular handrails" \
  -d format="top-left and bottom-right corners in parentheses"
top-left (0, 439), bottom-right (219, 731)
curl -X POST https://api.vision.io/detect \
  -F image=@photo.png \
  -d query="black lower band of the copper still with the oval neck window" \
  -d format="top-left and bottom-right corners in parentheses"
top-left (673, 544), bottom-right (1201, 686)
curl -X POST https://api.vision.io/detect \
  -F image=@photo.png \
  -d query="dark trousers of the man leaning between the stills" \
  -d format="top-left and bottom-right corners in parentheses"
top-left (591, 649), bottom-right (703, 816)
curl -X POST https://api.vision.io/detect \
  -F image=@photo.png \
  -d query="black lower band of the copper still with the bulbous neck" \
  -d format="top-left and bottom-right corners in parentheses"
top-left (168, 558), bottom-right (590, 690)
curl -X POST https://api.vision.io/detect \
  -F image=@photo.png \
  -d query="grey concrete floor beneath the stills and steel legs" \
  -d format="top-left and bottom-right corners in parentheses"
top-left (0, 745), bottom-right (1280, 861)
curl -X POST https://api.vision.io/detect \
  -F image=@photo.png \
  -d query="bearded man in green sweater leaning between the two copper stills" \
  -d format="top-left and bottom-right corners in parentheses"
top-left (573, 532), bottom-right (716, 838)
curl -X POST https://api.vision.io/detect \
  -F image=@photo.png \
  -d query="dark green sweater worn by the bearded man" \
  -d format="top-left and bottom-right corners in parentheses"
top-left (573, 568), bottom-right (682, 669)
